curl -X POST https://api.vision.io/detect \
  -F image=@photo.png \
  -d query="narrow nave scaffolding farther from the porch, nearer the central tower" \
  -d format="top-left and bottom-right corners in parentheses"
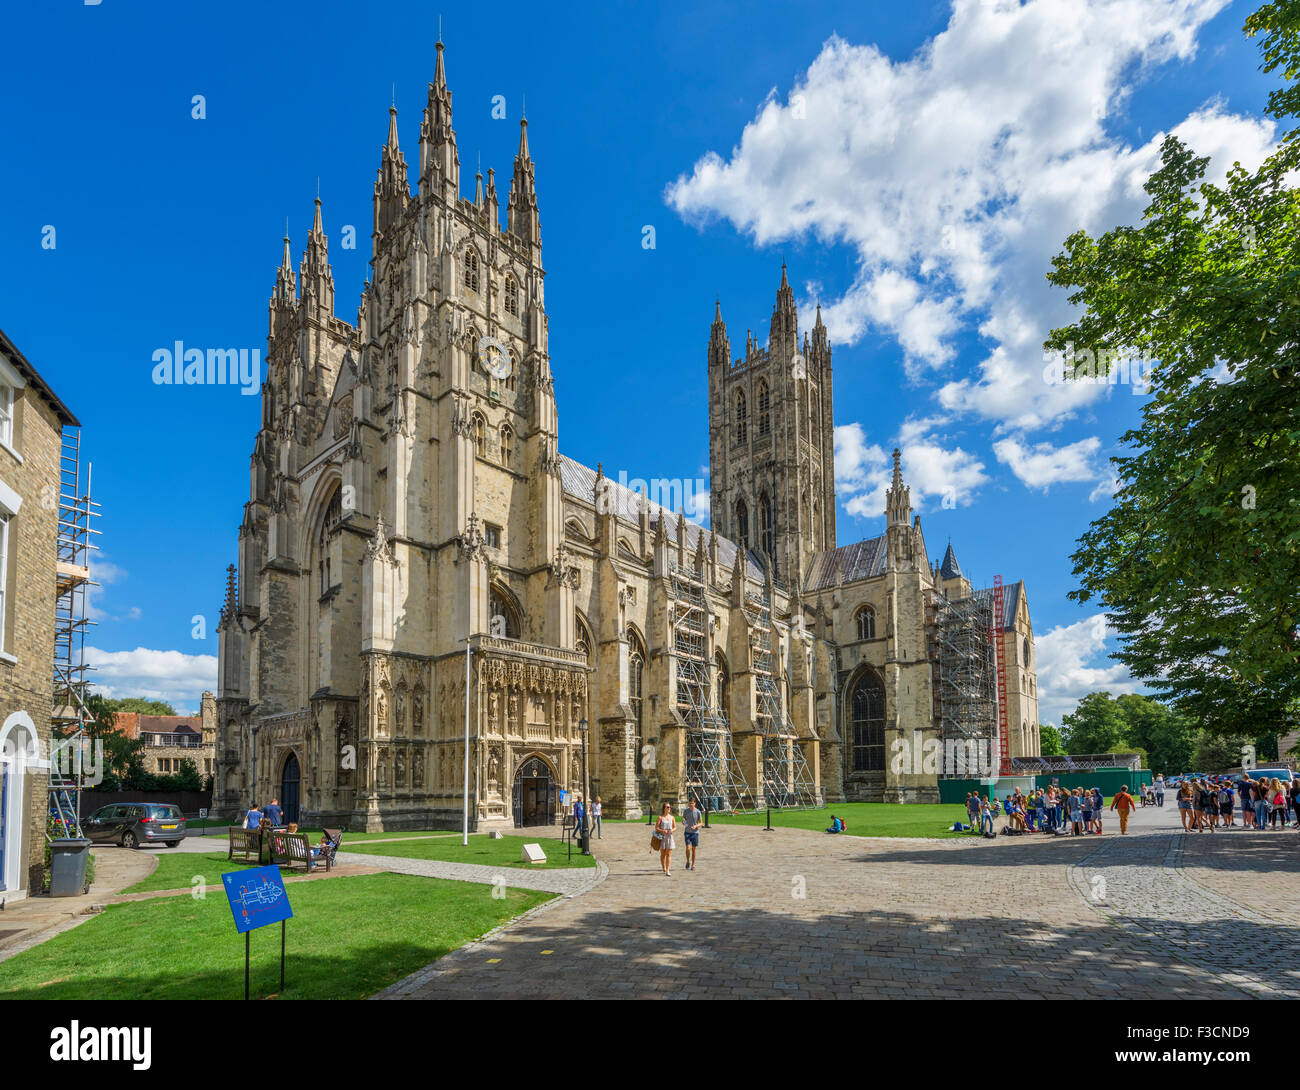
top-left (745, 589), bottom-right (826, 810)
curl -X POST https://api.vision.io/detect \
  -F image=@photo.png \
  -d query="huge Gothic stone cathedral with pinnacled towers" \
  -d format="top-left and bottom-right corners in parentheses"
top-left (213, 42), bottom-right (1039, 831)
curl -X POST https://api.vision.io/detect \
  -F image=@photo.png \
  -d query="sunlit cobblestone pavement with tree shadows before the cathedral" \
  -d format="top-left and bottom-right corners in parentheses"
top-left (374, 805), bottom-right (1300, 999)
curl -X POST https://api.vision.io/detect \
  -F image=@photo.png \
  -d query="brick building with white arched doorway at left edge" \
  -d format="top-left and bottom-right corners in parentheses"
top-left (0, 333), bottom-right (77, 900)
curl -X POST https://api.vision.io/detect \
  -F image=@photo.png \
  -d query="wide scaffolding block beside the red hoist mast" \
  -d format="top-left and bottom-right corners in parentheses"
top-left (935, 594), bottom-right (997, 778)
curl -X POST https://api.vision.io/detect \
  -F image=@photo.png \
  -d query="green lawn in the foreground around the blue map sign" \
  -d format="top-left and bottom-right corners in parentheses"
top-left (0, 874), bottom-right (553, 1000)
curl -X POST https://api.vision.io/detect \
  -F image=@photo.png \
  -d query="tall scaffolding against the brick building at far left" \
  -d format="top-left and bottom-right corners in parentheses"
top-left (49, 428), bottom-right (100, 836)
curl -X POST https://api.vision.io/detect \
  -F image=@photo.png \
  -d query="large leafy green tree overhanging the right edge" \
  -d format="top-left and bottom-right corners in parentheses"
top-left (1045, 4), bottom-right (1300, 736)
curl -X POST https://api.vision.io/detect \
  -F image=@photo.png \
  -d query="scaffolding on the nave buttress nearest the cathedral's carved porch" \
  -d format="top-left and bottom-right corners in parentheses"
top-left (670, 563), bottom-right (755, 812)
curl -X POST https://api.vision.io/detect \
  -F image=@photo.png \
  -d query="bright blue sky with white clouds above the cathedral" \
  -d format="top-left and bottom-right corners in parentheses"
top-left (0, 0), bottom-right (1274, 721)
